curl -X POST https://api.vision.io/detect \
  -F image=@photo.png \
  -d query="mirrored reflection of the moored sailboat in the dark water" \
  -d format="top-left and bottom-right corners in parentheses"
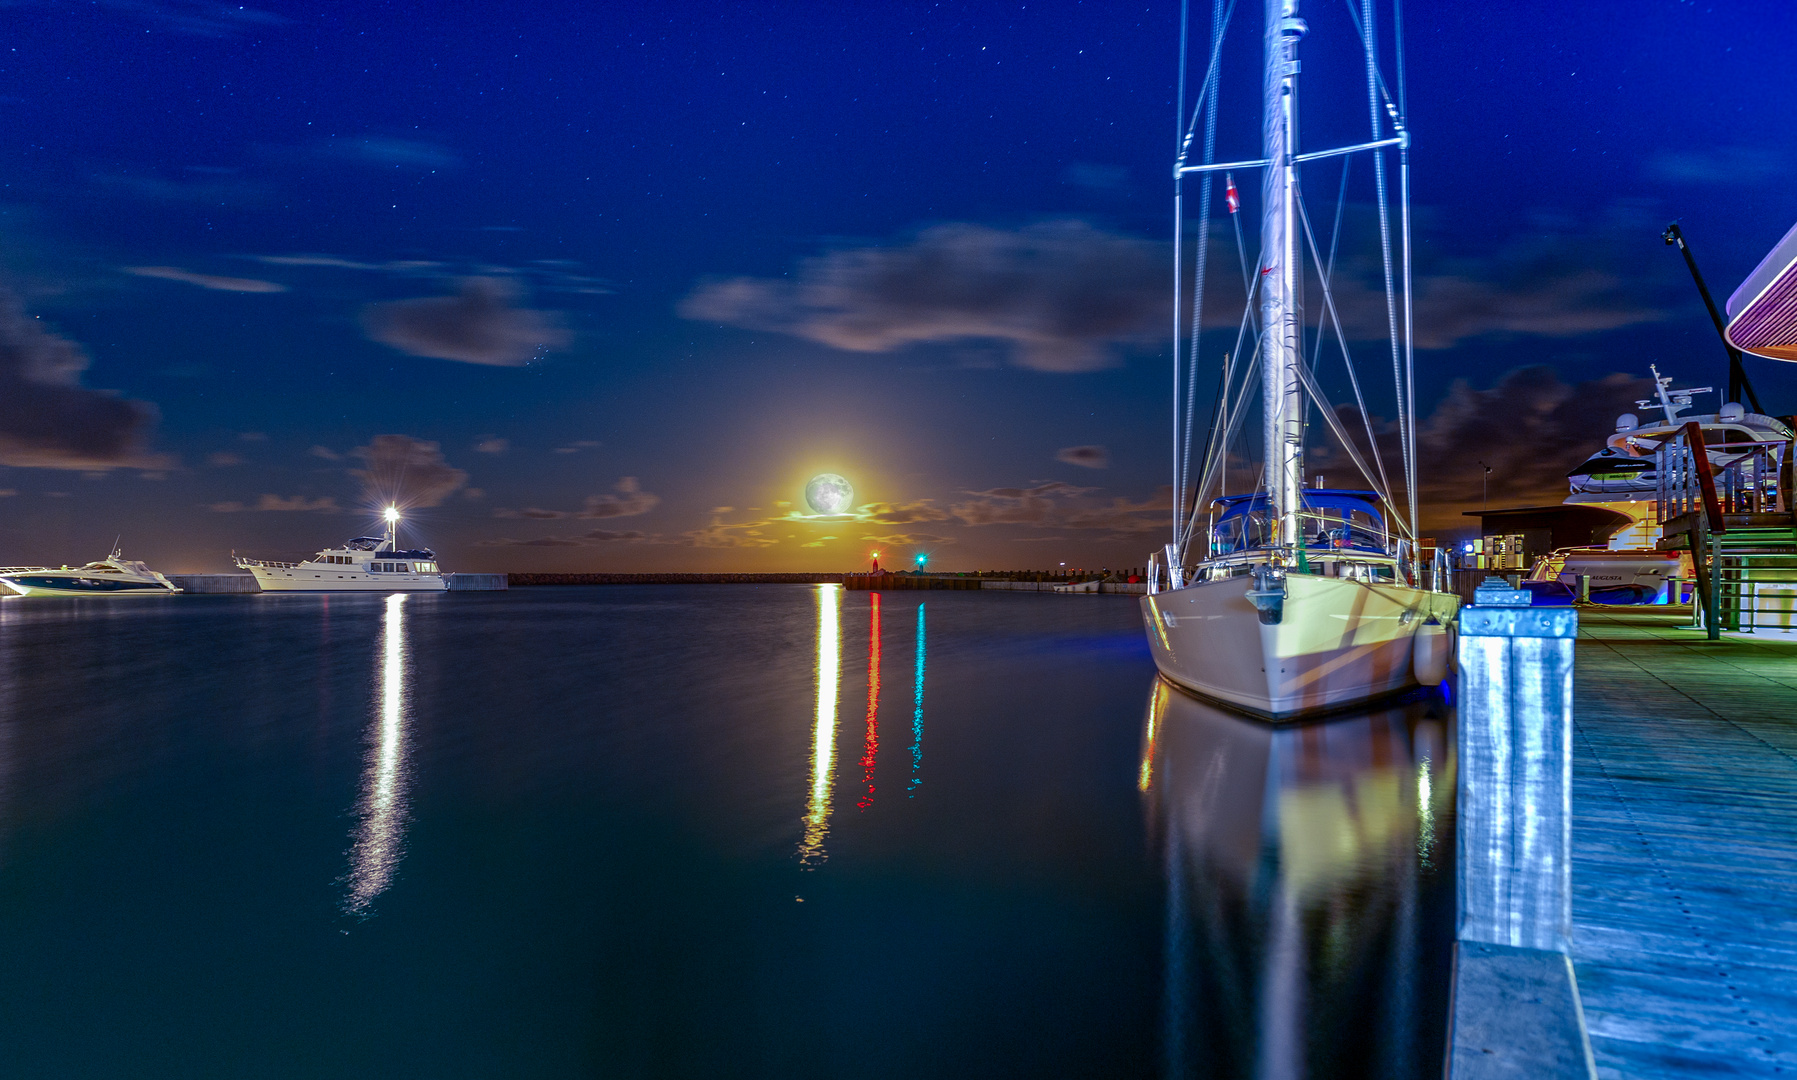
top-left (1139, 679), bottom-right (1454, 1080)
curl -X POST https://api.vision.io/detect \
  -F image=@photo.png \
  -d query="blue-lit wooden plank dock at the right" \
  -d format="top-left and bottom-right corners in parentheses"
top-left (1572, 609), bottom-right (1797, 1080)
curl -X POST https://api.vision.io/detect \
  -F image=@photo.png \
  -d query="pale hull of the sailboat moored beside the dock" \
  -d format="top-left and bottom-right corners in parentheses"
top-left (1141, 573), bottom-right (1459, 719)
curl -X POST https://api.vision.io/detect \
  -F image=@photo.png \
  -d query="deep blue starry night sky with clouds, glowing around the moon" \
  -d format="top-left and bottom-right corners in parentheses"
top-left (0, 0), bottom-right (1797, 571)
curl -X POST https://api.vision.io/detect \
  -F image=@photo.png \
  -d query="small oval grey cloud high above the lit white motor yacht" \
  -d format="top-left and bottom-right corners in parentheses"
top-left (361, 277), bottom-right (570, 367)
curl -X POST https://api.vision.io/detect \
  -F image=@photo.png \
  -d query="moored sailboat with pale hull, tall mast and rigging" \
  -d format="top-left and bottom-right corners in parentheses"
top-left (1141, 0), bottom-right (1459, 719)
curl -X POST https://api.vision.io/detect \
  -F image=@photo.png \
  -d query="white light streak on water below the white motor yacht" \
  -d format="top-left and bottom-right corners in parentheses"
top-left (343, 593), bottom-right (408, 915)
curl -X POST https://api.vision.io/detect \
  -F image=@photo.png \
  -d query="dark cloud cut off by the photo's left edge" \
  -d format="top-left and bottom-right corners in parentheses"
top-left (0, 291), bottom-right (169, 471)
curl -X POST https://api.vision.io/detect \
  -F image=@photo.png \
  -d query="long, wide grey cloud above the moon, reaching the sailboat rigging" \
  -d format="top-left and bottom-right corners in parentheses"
top-left (679, 221), bottom-right (1170, 372)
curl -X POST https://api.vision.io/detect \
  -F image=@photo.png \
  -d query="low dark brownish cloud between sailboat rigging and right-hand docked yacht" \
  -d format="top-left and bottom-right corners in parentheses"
top-left (1315, 365), bottom-right (1653, 532)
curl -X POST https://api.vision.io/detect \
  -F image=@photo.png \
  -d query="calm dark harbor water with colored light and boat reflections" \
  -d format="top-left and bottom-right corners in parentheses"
top-left (0, 586), bottom-right (1454, 1078)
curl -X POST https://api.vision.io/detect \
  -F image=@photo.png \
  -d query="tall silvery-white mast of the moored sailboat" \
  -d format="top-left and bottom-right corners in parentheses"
top-left (1260, 0), bottom-right (1305, 546)
